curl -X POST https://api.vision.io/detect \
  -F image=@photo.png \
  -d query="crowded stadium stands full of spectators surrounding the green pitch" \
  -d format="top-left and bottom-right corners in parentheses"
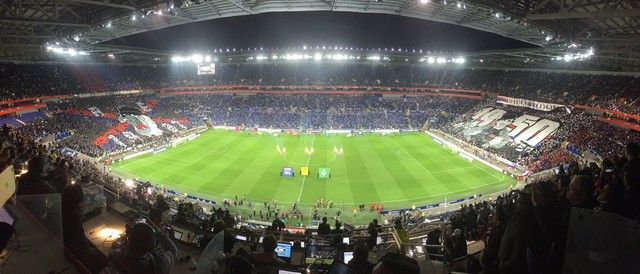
top-left (0, 62), bottom-right (640, 273)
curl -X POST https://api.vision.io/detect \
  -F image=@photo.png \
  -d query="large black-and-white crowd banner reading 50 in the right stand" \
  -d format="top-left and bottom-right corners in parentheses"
top-left (454, 108), bottom-right (560, 155)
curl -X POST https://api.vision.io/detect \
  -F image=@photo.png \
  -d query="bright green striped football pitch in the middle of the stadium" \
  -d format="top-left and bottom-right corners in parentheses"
top-left (111, 130), bottom-right (515, 209)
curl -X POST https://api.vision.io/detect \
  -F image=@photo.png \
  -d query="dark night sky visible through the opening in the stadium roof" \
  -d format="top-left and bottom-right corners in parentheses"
top-left (107, 12), bottom-right (533, 52)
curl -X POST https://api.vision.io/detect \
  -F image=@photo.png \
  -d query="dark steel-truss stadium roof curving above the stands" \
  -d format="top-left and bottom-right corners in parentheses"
top-left (0, 0), bottom-right (640, 72)
